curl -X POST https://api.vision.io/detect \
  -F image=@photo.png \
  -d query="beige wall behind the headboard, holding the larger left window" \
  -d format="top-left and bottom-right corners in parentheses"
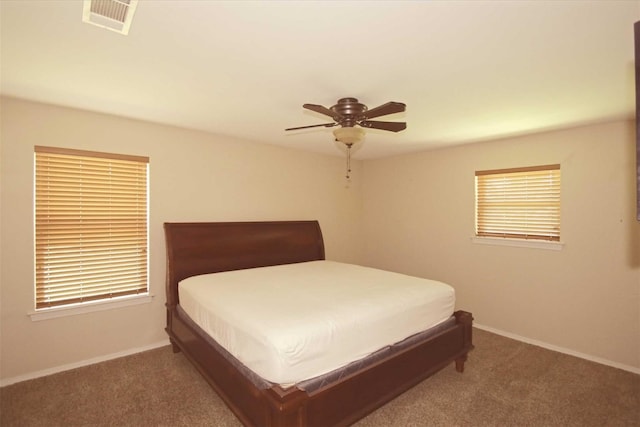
top-left (0, 98), bottom-right (362, 379)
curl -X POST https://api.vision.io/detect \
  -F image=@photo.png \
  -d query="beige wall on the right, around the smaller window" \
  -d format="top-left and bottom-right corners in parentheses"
top-left (363, 121), bottom-right (640, 372)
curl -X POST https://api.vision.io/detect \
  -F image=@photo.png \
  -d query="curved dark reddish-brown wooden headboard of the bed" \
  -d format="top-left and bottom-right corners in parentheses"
top-left (164, 221), bottom-right (324, 306)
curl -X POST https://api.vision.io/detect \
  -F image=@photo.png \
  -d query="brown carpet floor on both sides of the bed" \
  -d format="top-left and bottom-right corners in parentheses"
top-left (0, 329), bottom-right (640, 427)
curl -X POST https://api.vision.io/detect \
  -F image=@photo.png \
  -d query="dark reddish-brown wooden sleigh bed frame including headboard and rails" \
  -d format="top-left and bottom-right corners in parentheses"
top-left (164, 221), bottom-right (473, 427)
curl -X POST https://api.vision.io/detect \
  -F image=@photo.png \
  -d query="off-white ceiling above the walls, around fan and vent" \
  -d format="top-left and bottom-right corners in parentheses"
top-left (0, 0), bottom-right (640, 159)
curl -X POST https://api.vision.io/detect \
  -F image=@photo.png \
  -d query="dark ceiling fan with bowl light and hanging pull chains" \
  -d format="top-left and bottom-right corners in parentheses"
top-left (285, 98), bottom-right (407, 179)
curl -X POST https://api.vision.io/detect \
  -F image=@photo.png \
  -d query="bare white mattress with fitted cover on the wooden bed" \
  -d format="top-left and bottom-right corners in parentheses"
top-left (178, 261), bottom-right (455, 386)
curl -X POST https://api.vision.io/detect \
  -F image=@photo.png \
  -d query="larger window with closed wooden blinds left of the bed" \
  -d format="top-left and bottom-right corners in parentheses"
top-left (35, 146), bottom-right (149, 309)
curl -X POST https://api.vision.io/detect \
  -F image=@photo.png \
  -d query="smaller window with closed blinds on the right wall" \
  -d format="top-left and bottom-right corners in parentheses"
top-left (476, 165), bottom-right (560, 241)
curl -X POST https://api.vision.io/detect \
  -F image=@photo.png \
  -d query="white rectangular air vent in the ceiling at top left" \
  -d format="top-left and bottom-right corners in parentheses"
top-left (82, 0), bottom-right (138, 35)
